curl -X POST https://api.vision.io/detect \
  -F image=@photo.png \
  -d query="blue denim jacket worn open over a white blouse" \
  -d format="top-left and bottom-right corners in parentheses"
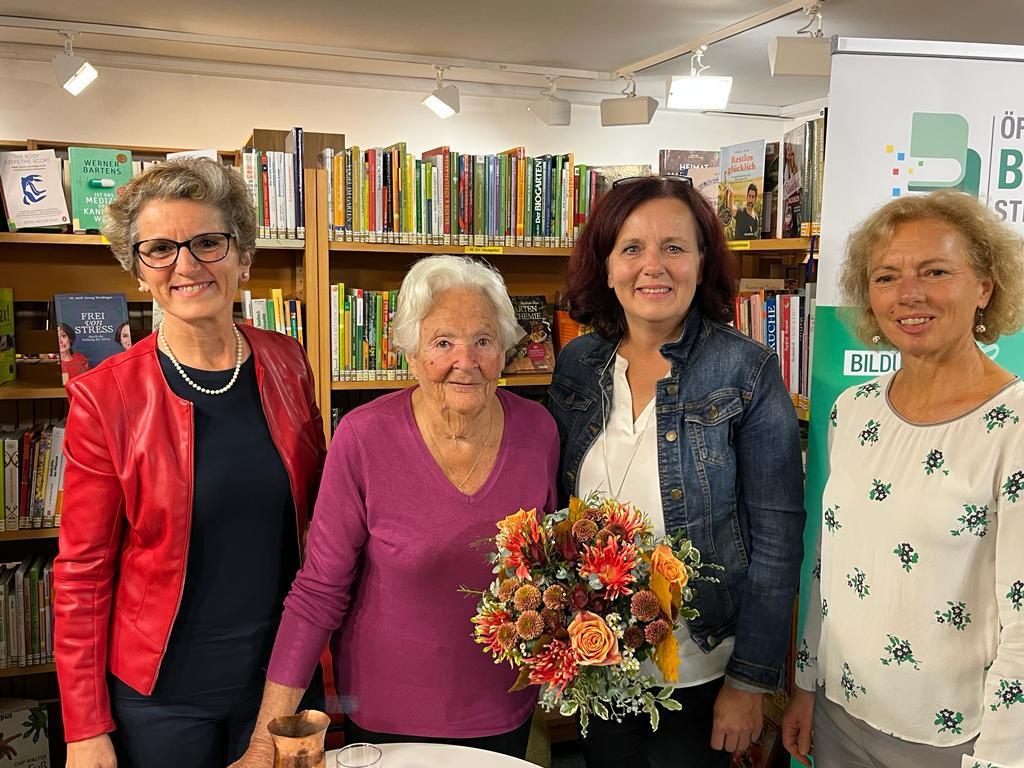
top-left (548, 306), bottom-right (805, 688)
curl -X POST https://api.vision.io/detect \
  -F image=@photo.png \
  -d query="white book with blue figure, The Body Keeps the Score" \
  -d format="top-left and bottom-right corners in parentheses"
top-left (0, 150), bottom-right (69, 232)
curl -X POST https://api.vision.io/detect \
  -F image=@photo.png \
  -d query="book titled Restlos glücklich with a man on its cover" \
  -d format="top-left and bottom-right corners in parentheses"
top-left (718, 139), bottom-right (765, 240)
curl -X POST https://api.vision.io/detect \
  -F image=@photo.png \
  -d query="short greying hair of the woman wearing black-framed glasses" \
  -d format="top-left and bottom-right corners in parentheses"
top-left (102, 158), bottom-right (258, 278)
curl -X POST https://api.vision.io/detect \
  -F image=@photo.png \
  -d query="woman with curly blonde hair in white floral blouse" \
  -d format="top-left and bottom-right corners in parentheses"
top-left (782, 191), bottom-right (1024, 768)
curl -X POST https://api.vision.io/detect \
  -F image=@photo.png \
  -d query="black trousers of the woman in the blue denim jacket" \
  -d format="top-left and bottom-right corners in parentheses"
top-left (583, 678), bottom-right (732, 768)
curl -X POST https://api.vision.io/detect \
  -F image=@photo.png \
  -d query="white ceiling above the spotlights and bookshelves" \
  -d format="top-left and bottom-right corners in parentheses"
top-left (0, 0), bottom-right (1024, 108)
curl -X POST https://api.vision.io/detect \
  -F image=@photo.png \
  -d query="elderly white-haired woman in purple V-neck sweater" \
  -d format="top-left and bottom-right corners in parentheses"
top-left (236, 256), bottom-right (558, 767)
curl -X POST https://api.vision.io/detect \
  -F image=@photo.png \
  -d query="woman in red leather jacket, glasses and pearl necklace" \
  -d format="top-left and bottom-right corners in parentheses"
top-left (54, 159), bottom-right (325, 768)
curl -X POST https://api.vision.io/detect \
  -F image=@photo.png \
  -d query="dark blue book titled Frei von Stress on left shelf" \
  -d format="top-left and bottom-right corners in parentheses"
top-left (53, 293), bottom-right (131, 384)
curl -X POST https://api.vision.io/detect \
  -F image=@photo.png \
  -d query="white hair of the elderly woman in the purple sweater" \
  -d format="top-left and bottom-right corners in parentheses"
top-left (393, 254), bottom-right (525, 355)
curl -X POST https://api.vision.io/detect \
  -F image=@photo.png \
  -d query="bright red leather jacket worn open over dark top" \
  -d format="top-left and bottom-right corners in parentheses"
top-left (53, 326), bottom-right (325, 741)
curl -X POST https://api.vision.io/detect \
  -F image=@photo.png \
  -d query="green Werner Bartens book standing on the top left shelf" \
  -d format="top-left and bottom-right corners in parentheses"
top-left (68, 146), bottom-right (131, 232)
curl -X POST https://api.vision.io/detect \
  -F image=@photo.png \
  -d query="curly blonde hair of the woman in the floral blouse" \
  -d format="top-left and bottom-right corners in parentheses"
top-left (839, 189), bottom-right (1024, 344)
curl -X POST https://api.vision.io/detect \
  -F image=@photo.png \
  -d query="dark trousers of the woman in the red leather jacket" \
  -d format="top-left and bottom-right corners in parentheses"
top-left (108, 667), bottom-right (324, 768)
